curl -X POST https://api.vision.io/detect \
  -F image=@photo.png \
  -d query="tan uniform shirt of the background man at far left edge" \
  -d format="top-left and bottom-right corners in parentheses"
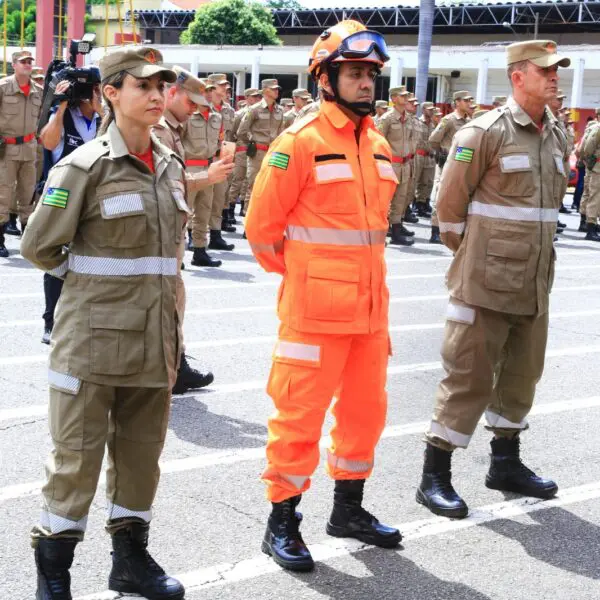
top-left (0, 75), bottom-right (42, 160)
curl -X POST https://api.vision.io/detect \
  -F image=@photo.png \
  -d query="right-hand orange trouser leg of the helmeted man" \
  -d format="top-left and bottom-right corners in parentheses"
top-left (327, 329), bottom-right (390, 479)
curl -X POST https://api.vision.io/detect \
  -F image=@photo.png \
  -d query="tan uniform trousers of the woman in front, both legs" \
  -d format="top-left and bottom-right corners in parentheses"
top-left (32, 381), bottom-right (171, 539)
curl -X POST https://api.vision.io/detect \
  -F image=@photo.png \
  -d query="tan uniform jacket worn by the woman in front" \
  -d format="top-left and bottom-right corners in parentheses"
top-left (21, 123), bottom-right (188, 387)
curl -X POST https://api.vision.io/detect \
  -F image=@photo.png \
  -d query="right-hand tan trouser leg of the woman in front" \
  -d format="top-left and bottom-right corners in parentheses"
top-left (106, 387), bottom-right (171, 533)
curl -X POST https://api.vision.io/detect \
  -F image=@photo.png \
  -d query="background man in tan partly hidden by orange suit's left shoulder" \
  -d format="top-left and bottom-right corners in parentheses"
top-left (238, 79), bottom-right (283, 217)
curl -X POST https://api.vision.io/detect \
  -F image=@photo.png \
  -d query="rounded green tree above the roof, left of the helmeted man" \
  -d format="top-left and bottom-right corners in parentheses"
top-left (180, 0), bottom-right (281, 46)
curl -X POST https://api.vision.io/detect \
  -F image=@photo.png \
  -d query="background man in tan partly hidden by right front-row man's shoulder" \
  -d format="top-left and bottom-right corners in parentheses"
top-left (429, 90), bottom-right (473, 244)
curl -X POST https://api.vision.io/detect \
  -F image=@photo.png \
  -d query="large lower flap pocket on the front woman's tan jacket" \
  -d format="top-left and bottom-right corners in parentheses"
top-left (90, 304), bottom-right (146, 375)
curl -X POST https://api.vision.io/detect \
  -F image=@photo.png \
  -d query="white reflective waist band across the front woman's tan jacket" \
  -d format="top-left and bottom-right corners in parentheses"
top-left (69, 254), bottom-right (177, 277)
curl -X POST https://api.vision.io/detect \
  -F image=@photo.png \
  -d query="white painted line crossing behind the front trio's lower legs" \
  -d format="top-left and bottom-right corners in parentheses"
top-left (0, 396), bottom-right (600, 505)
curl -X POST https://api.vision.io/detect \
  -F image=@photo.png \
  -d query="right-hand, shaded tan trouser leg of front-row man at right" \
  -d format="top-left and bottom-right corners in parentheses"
top-left (485, 313), bottom-right (548, 434)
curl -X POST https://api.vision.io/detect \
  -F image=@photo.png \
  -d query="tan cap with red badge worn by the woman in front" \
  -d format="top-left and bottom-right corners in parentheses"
top-left (100, 46), bottom-right (177, 83)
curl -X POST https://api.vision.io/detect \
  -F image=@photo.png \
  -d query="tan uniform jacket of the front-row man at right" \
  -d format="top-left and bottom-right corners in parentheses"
top-left (437, 99), bottom-right (567, 315)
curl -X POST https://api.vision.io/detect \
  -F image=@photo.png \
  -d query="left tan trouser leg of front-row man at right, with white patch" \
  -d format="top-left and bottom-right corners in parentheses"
top-left (426, 299), bottom-right (512, 449)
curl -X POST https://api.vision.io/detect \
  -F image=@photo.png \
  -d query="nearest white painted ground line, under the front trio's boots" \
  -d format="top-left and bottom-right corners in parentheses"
top-left (76, 482), bottom-right (600, 600)
